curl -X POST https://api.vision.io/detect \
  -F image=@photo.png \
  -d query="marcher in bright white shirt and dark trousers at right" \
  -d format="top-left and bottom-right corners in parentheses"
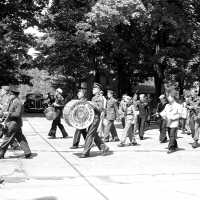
top-left (160, 90), bottom-right (182, 153)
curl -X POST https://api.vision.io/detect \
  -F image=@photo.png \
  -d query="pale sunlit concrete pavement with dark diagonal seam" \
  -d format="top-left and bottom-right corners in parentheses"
top-left (0, 115), bottom-right (200, 200)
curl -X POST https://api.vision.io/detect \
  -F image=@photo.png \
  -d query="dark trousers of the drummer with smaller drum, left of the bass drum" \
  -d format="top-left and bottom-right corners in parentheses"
top-left (49, 115), bottom-right (68, 137)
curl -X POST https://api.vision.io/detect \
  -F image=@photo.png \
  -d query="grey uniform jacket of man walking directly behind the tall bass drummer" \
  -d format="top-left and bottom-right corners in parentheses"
top-left (106, 97), bottom-right (118, 120)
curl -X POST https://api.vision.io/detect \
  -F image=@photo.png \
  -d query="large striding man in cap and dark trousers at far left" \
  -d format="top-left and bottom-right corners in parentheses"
top-left (0, 86), bottom-right (32, 159)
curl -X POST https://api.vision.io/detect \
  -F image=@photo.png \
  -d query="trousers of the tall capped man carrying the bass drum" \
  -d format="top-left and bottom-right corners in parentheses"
top-left (83, 115), bottom-right (106, 155)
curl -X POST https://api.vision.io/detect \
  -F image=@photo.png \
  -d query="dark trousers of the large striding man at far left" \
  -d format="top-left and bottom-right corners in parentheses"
top-left (0, 123), bottom-right (31, 156)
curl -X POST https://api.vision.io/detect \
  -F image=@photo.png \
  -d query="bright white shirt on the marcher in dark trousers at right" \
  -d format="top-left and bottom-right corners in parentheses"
top-left (160, 102), bottom-right (182, 128)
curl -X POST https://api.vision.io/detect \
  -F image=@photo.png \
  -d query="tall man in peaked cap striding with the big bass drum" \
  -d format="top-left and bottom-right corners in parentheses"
top-left (80, 83), bottom-right (109, 158)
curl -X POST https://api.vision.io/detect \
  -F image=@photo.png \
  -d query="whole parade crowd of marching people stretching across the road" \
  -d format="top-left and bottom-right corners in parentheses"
top-left (0, 83), bottom-right (200, 159)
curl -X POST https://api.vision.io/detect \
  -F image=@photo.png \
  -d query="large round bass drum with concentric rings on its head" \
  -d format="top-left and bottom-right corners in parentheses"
top-left (63, 100), bottom-right (94, 129)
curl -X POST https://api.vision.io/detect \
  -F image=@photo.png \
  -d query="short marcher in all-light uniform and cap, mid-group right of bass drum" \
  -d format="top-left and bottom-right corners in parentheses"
top-left (118, 96), bottom-right (138, 147)
